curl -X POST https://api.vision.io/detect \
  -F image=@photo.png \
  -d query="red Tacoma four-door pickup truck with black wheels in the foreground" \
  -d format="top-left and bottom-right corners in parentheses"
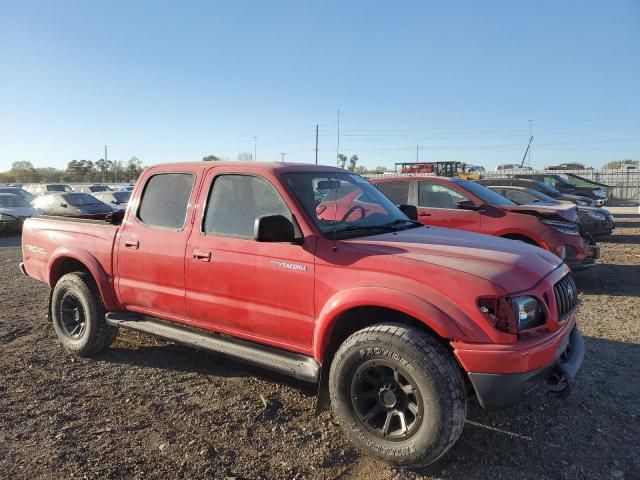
top-left (21, 162), bottom-right (584, 466)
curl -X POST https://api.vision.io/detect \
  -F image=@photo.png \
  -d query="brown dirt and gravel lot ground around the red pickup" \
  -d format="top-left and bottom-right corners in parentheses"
top-left (0, 215), bottom-right (640, 480)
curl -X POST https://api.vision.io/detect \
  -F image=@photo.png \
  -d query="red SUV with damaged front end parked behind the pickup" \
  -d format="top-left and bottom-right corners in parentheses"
top-left (370, 177), bottom-right (600, 270)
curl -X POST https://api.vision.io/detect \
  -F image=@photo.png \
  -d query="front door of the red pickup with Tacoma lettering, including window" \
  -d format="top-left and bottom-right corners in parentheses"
top-left (186, 167), bottom-right (315, 353)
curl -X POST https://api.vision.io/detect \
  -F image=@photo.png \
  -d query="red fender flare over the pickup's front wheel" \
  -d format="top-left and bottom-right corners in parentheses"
top-left (313, 287), bottom-right (465, 363)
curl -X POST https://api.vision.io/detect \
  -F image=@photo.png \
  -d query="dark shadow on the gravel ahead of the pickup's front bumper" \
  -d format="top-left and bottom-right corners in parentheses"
top-left (416, 337), bottom-right (640, 480)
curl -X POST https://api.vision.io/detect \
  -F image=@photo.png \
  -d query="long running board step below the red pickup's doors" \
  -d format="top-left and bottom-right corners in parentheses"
top-left (105, 312), bottom-right (320, 383)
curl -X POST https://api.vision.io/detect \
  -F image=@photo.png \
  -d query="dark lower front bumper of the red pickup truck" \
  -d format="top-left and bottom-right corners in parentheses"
top-left (468, 326), bottom-right (584, 409)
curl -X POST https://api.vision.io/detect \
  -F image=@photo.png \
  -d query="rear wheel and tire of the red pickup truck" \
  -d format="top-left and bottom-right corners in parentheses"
top-left (51, 272), bottom-right (118, 357)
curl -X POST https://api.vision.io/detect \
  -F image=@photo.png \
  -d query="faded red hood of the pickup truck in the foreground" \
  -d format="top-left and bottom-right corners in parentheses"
top-left (344, 227), bottom-right (562, 293)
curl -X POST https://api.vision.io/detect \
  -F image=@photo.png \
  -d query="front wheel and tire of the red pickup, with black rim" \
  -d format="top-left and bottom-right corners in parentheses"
top-left (329, 324), bottom-right (467, 467)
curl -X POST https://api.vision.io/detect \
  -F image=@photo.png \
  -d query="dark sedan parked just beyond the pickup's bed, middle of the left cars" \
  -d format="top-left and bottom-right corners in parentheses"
top-left (33, 192), bottom-right (112, 220)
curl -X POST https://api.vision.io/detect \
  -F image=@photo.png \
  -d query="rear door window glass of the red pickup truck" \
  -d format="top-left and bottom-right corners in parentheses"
top-left (138, 173), bottom-right (195, 230)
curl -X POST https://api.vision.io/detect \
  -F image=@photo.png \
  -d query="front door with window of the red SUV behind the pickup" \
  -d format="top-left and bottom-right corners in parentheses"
top-left (417, 180), bottom-right (481, 232)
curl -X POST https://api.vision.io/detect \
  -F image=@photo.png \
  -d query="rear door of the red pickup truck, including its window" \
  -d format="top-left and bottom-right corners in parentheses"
top-left (116, 167), bottom-right (204, 320)
